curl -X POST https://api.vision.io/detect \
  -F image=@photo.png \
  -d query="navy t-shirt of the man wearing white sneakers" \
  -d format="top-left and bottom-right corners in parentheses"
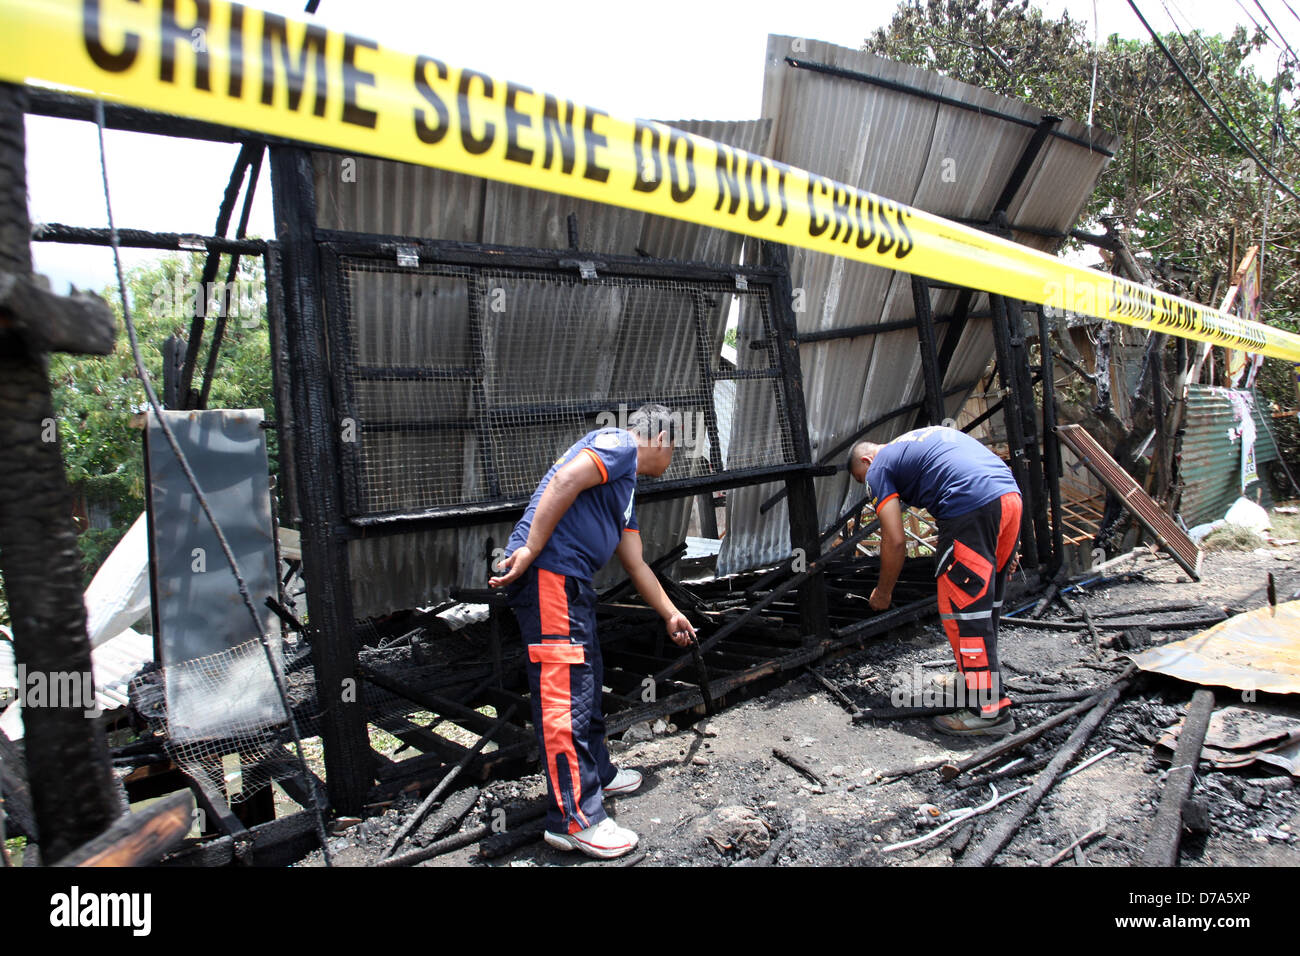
top-left (506, 428), bottom-right (638, 580)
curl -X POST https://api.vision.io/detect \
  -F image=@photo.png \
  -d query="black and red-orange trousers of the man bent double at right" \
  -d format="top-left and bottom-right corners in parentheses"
top-left (937, 492), bottom-right (1021, 717)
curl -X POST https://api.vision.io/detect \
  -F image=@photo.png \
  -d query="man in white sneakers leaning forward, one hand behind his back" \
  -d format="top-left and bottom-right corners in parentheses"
top-left (489, 405), bottom-right (694, 858)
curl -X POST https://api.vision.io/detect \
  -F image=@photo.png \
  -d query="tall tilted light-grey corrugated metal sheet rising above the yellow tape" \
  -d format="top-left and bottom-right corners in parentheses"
top-left (719, 36), bottom-right (1118, 574)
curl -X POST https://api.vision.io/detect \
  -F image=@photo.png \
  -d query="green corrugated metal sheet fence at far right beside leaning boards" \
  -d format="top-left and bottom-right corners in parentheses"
top-left (1178, 385), bottom-right (1278, 527)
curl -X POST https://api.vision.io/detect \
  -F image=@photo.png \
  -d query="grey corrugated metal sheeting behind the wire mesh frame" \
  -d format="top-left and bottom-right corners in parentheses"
top-left (313, 121), bottom-right (775, 617)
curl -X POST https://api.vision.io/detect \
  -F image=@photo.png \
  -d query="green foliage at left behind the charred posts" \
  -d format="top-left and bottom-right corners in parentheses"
top-left (49, 254), bottom-right (274, 581)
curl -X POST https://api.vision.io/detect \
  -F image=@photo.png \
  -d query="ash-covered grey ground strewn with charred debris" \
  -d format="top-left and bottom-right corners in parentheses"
top-left (297, 545), bottom-right (1300, 866)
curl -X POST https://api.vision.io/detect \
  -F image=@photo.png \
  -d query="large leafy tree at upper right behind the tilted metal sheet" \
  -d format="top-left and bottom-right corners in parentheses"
top-left (865, 0), bottom-right (1300, 478)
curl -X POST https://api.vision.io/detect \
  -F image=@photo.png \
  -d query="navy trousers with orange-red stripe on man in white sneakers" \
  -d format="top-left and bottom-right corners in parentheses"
top-left (511, 566), bottom-right (618, 834)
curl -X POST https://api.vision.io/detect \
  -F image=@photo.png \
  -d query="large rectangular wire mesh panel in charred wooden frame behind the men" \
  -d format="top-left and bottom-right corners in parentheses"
top-left (319, 254), bottom-right (797, 518)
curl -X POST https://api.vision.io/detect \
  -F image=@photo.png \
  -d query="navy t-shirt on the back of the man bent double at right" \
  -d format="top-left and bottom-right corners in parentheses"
top-left (867, 425), bottom-right (1021, 520)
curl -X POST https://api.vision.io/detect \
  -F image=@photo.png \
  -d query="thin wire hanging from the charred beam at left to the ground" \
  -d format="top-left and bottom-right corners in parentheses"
top-left (95, 99), bottom-right (332, 866)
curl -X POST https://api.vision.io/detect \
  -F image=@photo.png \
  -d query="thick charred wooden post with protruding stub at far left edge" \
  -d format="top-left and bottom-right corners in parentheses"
top-left (0, 85), bottom-right (118, 862)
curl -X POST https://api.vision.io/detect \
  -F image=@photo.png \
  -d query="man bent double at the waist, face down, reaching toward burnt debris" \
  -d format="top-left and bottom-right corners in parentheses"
top-left (849, 425), bottom-right (1022, 735)
